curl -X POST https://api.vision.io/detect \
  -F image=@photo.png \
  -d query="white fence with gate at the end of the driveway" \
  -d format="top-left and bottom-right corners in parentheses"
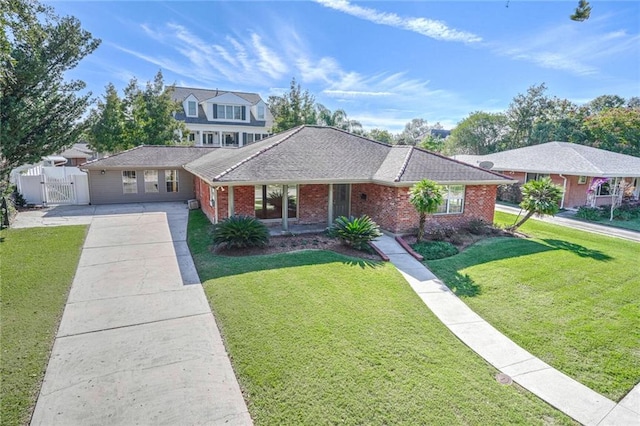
top-left (16, 167), bottom-right (90, 205)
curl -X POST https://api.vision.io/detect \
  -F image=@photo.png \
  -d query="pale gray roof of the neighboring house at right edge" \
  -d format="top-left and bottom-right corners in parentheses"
top-left (455, 142), bottom-right (640, 177)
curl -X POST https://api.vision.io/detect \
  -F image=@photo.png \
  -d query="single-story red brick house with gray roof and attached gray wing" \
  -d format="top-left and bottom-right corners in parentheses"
top-left (83, 126), bottom-right (514, 233)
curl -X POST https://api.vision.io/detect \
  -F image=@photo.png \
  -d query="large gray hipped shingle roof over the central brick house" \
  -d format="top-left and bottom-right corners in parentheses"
top-left (185, 126), bottom-right (510, 184)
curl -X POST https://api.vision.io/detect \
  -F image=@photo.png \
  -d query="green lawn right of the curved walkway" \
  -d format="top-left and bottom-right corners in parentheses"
top-left (428, 212), bottom-right (640, 400)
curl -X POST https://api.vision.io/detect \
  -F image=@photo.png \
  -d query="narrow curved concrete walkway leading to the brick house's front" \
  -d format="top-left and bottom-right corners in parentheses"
top-left (375, 235), bottom-right (640, 425)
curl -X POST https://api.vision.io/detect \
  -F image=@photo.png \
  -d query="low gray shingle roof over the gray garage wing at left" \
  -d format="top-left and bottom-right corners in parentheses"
top-left (82, 145), bottom-right (218, 170)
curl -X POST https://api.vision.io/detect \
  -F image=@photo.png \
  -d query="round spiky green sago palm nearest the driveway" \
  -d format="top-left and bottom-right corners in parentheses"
top-left (213, 216), bottom-right (269, 248)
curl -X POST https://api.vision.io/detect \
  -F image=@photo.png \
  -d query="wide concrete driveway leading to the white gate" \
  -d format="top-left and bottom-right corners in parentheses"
top-left (28, 203), bottom-right (252, 425)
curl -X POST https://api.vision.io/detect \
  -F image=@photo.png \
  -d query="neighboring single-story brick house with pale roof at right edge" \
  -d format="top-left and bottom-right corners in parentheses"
top-left (453, 142), bottom-right (640, 208)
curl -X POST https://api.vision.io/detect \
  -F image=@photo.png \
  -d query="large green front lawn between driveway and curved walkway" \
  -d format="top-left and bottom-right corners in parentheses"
top-left (188, 211), bottom-right (571, 425)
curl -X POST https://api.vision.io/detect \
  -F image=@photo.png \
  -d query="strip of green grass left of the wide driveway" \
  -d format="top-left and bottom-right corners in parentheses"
top-left (0, 226), bottom-right (86, 425)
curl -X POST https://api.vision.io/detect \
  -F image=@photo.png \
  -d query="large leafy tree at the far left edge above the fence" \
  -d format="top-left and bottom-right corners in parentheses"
top-left (0, 0), bottom-right (100, 186)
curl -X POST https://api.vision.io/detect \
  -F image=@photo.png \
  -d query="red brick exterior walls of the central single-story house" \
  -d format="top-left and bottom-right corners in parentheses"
top-left (196, 178), bottom-right (496, 234)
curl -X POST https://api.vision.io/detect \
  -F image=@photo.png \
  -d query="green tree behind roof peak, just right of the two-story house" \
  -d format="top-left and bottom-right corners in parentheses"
top-left (267, 78), bottom-right (318, 133)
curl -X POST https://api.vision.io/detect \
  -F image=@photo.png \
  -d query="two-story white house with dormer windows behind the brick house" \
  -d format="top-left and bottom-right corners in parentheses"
top-left (172, 87), bottom-right (273, 147)
